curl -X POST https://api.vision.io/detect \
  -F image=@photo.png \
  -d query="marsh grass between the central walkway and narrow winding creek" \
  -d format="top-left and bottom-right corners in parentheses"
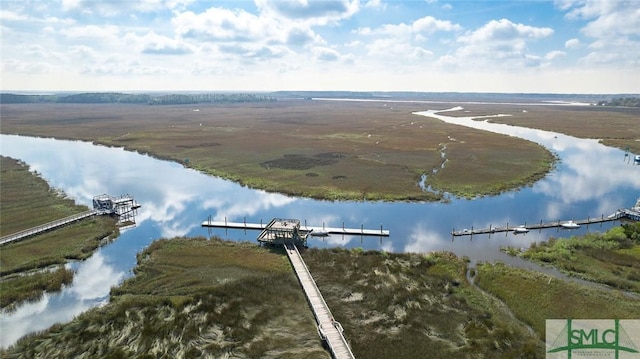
top-left (303, 249), bottom-right (542, 358)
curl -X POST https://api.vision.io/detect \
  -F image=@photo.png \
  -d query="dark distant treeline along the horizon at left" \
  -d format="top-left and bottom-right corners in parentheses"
top-left (0, 92), bottom-right (276, 105)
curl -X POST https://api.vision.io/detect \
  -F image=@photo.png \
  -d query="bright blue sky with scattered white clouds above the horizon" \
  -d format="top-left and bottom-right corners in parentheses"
top-left (0, 0), bottom-right (640, 94)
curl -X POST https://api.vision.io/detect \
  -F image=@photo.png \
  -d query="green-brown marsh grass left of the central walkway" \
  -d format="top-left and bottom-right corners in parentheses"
top-left (1, 238), bottom-right (329, 358)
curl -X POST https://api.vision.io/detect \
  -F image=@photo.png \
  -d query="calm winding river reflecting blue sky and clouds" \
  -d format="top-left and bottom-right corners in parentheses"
top-left (0, 105), bottom-right (640, 347)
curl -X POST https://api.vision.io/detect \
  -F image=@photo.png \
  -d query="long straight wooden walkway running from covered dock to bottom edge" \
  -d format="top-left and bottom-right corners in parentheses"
top-left (284, 243), bottom-right (354, 359)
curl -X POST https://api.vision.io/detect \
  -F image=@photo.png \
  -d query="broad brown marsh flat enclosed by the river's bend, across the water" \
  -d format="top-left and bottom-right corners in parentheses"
top-left (2, 101), bottom-right (554, 201)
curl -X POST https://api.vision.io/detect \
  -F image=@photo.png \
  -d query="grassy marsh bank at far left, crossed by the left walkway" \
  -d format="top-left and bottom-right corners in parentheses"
top-left (0, 157), bottom-right (117, 308)
